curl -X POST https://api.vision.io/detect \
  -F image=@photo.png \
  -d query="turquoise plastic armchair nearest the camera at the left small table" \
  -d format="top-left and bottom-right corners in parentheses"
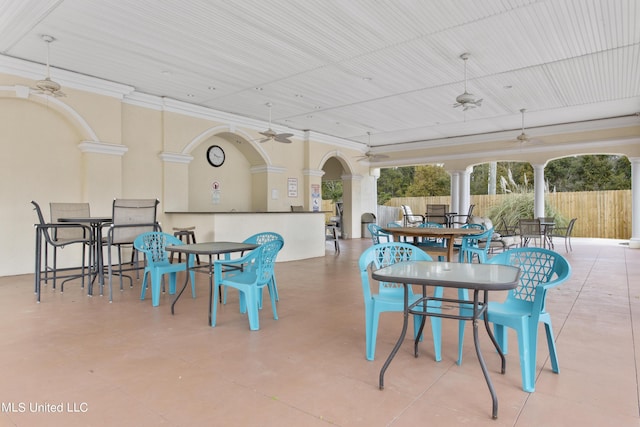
top-left (209, 240), bottom-right (283, 331)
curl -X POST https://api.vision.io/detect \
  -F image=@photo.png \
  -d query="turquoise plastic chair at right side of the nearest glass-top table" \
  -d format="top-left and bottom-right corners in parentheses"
top-left (487, 247), bottom-right (571, 393)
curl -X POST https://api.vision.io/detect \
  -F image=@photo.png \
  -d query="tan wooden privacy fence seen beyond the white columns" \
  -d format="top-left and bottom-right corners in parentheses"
top-left (386, 190), bottom-right (640, 239)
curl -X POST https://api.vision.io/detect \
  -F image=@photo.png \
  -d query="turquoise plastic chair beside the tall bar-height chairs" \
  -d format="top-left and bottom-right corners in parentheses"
top-left (133, 231), bottom-right (196, 307)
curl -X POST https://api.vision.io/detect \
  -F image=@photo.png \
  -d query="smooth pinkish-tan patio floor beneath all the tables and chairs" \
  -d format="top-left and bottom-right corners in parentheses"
top-left (0, 239), bottom-right (640, 427)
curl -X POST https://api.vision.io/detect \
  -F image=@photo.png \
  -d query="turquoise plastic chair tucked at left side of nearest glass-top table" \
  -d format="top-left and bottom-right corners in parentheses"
top-left (358, 242), bottom-right (443, 361)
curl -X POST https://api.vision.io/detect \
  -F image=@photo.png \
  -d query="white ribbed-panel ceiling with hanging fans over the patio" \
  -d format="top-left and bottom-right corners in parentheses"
top-left (0, 0), bottom-right (640, 166)
